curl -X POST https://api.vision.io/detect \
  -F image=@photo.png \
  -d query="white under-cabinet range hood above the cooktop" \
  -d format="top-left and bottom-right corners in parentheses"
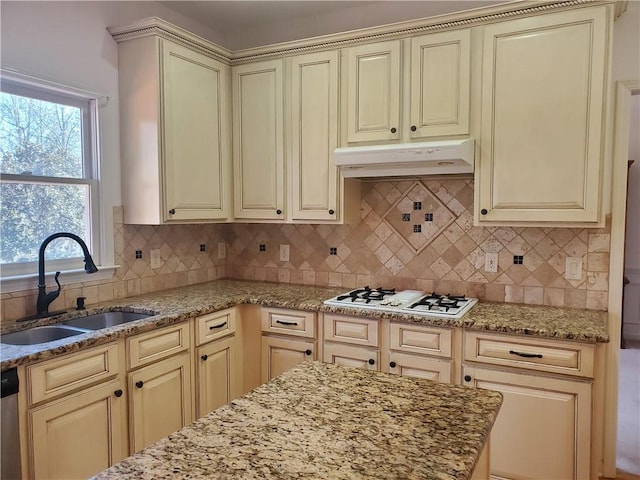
top-left (333, 139), bottom-right (474, 178)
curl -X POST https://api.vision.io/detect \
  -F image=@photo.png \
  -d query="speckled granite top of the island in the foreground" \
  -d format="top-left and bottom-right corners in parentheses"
top-left (94, 362), bottom-right (502, 480)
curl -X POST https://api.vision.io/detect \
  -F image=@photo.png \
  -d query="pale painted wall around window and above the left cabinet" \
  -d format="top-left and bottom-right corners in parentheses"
top-left (0, 0), bottom-right (225, 265)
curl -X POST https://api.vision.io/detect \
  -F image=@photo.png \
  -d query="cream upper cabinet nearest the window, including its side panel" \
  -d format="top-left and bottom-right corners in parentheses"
top-left (118, 35), bottom-right (231, 224)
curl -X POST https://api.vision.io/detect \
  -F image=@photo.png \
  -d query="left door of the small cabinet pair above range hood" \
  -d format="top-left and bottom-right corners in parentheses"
top-left (347, 40), bottom-right (401, 143)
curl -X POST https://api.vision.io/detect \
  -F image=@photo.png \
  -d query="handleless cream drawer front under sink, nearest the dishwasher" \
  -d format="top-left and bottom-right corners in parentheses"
top-left (26, 343), bottom-right (119, 405)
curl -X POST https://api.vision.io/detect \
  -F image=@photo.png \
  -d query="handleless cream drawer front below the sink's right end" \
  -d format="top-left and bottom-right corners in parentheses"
top-left (127, 322), bottom-right (189, 369)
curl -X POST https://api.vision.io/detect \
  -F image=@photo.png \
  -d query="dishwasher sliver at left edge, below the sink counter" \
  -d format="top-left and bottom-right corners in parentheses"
top-left (0, 368), bottom-right (21, 480)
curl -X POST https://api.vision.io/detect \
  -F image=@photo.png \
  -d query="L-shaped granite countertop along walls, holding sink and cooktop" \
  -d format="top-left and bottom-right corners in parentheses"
top-left (0, 280), bottom-right (609, 369)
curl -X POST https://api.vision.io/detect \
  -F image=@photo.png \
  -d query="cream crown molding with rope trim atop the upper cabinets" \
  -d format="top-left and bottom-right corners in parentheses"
top-left (107, 0), bottom-right (616, 65)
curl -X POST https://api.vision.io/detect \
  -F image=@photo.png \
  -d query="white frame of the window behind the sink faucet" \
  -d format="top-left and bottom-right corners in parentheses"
top-left (0, 71), bottom-right (103, 278)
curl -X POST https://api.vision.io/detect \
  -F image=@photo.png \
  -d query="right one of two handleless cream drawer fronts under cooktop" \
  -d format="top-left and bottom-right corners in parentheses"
top-left (389, 323), bottom-right (451, 358)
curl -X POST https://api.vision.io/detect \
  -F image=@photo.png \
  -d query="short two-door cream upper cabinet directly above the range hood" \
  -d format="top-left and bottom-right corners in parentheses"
top-left (346, 29), bottom-right (471, 143)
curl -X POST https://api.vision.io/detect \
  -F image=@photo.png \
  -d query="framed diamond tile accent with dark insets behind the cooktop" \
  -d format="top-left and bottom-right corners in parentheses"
top-left (382, 182), bottom-right (456, 253)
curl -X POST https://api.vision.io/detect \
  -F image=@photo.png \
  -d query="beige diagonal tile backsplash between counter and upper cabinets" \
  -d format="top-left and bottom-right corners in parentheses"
top-left (1, 179), bottom-right (610, 322)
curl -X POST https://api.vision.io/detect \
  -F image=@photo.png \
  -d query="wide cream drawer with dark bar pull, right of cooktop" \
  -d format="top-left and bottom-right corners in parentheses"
top-left (464, 332), bottom-right (595, 378)
